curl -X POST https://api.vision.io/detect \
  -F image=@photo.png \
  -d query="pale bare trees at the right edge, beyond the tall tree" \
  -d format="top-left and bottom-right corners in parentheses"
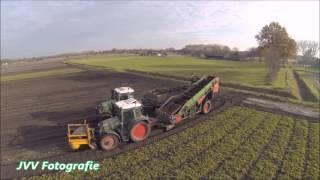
top-left (298, 40), bottom-right (319, 58)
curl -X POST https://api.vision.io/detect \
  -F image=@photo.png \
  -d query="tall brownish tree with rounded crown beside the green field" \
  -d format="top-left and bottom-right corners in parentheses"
top-left (255, 22), bottom-right (297, 81)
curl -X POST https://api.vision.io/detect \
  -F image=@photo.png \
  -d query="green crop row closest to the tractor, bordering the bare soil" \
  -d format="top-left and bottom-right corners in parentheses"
top-left (31, 108), bottom-right (245, 179)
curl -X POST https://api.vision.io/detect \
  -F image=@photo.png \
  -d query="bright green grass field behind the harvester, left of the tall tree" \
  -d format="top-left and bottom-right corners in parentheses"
top-left (70, 56), bottom-right (267, 86)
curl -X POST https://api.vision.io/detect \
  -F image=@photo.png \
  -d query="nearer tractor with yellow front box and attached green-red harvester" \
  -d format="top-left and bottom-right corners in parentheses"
top-left (68, 76), bottom-right (220, 150)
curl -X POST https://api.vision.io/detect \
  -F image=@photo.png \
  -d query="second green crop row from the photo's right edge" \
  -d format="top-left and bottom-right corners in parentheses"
top-left (278, 121), bottom-right (308, 179)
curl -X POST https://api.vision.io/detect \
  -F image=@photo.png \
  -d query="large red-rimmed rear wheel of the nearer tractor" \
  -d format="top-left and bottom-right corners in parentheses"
top-left (130, 121), bottom-right (151, 142)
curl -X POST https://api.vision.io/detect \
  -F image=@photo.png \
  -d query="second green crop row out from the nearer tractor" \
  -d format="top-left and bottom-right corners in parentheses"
top-left (109, 107), bottom-right (249, 179)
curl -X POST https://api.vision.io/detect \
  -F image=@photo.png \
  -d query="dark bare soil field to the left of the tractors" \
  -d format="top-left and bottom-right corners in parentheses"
top-left (1, 68), bottom-right (181, 164)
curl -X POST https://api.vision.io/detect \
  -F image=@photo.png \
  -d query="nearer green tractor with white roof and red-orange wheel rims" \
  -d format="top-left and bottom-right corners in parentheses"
top-left (96, 98), bottom-right (151, 150)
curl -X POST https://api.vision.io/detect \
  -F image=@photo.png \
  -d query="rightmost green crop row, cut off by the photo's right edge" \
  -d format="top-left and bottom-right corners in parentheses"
top-left (304, 123), bottom-right (320, 179)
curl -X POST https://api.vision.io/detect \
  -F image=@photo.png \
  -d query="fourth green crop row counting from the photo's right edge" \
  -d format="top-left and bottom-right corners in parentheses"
top-left (213, 113), bottom-right (279, 179)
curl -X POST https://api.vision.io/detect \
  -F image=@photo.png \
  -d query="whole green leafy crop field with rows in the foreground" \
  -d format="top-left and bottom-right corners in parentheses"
top-left (33, 107), bottom-right (320, 179)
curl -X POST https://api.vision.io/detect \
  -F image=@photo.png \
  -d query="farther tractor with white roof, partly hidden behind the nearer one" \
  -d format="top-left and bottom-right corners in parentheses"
top-left (96, 87), bottom-right (134, 119)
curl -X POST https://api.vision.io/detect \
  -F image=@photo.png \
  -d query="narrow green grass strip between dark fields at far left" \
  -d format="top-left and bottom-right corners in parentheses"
top-left (1, 68), bottom-right (83, 82)
